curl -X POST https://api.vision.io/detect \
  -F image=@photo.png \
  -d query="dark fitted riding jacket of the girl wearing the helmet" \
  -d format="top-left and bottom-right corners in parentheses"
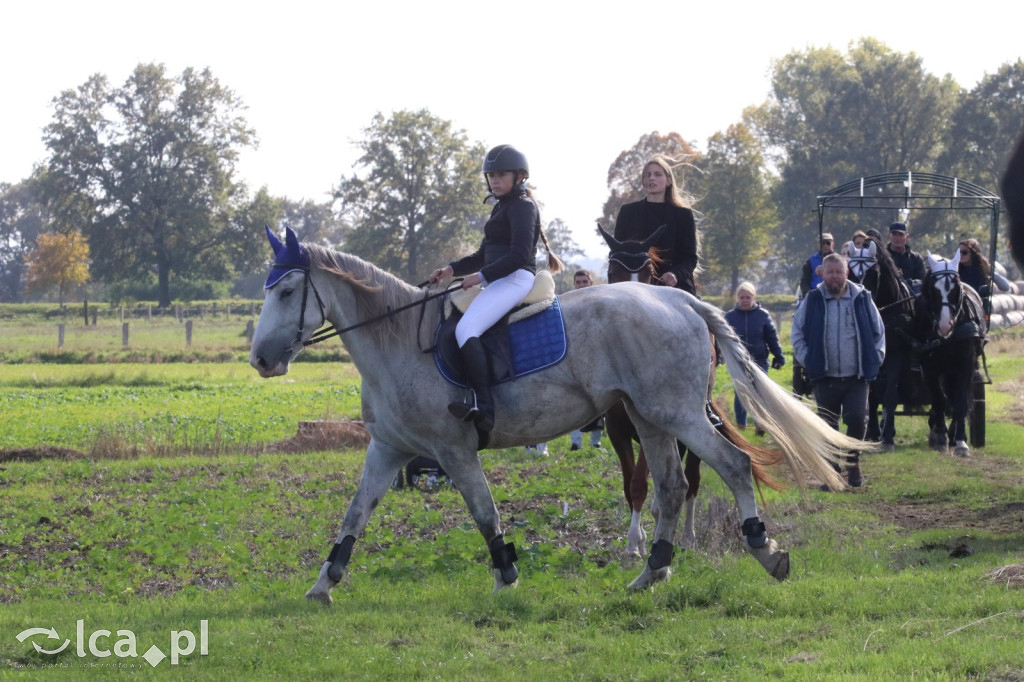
top-left (450, 187), bottom-right (541, 283)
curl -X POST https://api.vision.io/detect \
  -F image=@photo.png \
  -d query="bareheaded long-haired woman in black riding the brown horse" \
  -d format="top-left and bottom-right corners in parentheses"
top-left (613, 155), bottom-right (722, 426)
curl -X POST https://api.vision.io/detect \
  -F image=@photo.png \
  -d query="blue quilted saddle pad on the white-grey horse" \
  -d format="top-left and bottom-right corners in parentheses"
top-left (434, 296), bottom-right (568, 388)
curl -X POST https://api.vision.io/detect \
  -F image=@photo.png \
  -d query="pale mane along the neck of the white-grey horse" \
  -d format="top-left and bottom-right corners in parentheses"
top-left (302, 244), bottom-right (430, 342)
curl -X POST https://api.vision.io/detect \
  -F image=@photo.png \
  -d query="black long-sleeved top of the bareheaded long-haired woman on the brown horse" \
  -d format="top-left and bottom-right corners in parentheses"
top-left (614, 199), bottom-right (697, 295)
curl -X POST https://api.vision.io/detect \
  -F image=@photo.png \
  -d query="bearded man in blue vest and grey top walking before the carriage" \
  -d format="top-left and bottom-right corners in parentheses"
top-left (792, 253), bottom-right (886, 487)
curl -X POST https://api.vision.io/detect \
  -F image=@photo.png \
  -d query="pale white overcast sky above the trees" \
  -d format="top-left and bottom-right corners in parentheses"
top-left (0, 0), bottom-right (1024, 256)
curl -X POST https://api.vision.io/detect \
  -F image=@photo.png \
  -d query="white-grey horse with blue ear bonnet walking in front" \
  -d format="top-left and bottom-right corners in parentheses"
top-left (250, 229), bottom-right (863, 604)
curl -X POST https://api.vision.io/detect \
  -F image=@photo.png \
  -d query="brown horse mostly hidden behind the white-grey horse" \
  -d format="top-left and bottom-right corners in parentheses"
top-left (598, 225), bottom-right (782, 556)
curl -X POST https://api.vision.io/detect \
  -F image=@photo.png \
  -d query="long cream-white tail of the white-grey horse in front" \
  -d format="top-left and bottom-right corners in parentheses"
top-left (688, 297), bottom-right (871, 491)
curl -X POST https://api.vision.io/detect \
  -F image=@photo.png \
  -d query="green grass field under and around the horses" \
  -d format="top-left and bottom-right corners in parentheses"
top-left (0, 321), bottom-right (1024, 680)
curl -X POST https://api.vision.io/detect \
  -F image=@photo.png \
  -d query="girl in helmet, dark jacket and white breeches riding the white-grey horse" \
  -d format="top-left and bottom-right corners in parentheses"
top-left (430, 144), bottom-right (562, 431)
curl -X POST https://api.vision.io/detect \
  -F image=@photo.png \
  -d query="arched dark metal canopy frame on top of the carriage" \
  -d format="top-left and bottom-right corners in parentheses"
top-left (817, 171), bottom-right (1001, 272)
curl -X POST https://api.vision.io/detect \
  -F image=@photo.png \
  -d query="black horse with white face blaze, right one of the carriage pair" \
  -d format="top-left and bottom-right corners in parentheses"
top-left (914, 261), bottom-right (985, 457)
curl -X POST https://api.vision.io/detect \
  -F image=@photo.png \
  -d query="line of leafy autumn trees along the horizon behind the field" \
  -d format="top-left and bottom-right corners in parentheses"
top-left (0, 38), bottom-right (1024, 306)
